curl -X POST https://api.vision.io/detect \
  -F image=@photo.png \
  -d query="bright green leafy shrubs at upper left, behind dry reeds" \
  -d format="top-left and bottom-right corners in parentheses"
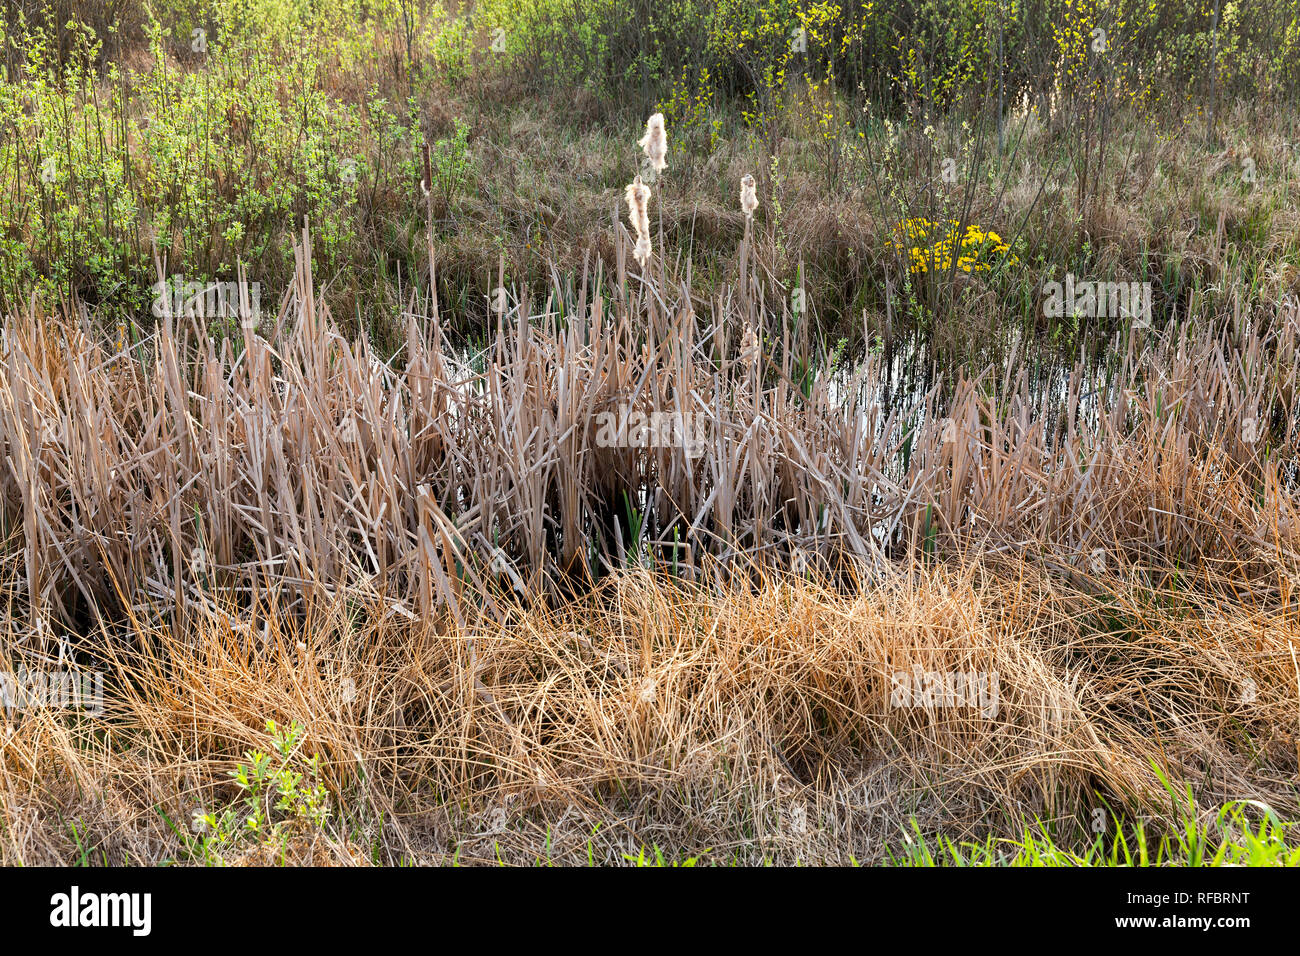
top-left (0, 0), bottom-right (384, 304)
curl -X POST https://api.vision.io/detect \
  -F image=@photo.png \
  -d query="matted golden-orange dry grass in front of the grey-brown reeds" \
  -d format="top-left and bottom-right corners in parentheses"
top-left (0, 562), bottom-right (1300, 865)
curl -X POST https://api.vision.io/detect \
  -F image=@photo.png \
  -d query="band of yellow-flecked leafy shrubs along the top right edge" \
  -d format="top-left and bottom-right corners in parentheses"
top-left (473, 0), bottom-right (1300, 120)
